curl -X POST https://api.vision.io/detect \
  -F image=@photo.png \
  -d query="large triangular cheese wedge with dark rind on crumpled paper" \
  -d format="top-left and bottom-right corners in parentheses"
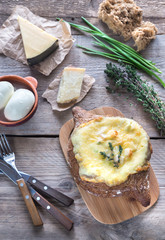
top-left (18, 16), bottom-right (58, 65)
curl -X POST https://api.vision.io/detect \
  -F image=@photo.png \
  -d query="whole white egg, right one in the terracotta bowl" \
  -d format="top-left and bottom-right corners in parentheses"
top-left (4, 89), bottom-right (35, 121)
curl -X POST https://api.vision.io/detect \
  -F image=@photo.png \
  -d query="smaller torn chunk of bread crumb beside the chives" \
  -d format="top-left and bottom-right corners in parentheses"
top-left (132, 22), bottom-right (157, 52)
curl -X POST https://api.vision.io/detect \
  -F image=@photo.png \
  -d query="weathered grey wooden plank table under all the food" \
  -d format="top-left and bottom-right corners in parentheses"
top-left (0, 0), bottom-right (165, 240)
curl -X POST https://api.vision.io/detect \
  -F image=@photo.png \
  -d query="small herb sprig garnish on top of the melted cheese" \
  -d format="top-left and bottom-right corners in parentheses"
top-left (100, 142), bottom-right (123, 168)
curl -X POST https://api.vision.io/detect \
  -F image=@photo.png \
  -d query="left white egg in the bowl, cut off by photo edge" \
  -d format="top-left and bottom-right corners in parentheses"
top-left (0, 81), bottom-right (14, 109)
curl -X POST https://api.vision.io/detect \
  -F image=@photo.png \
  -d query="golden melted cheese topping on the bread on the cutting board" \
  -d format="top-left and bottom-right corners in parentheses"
top-left (71, 117), bottom-right (149, 186)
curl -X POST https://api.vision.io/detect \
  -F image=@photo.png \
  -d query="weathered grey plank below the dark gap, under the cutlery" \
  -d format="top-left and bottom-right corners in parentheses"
top-left (0, 137), bottom-right (165, 240)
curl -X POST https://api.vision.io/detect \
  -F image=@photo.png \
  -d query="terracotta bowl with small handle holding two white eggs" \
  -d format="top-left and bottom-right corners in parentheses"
top-left (0, 75), bottom-right (38, 126)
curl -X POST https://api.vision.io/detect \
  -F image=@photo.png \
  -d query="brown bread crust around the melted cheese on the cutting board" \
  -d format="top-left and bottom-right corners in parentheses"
top-left (68, 107), bottom-right (152, 206)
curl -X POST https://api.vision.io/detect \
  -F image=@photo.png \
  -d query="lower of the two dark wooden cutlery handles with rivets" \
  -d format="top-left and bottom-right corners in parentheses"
top-left (32, 192), bottom-right (73, 230)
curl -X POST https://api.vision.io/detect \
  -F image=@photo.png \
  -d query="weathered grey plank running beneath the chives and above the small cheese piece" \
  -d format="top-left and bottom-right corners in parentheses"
top-left (0, 35), bottom-right (165, 89)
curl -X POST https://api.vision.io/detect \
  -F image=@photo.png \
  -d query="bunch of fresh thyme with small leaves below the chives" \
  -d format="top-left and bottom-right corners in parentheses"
top-left (105, 63), bottom-right (165, 136)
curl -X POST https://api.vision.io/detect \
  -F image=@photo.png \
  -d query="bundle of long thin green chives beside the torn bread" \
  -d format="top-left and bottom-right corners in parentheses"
top-left (57, 17), bottom-right (165, 87)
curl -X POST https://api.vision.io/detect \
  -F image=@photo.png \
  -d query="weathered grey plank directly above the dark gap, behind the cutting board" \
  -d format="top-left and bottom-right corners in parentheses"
top-left (0, 87), bottom-right (165, 137)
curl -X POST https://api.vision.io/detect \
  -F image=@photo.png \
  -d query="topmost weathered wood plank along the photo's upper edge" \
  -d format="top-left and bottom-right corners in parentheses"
top-left (0, 0), bottom-right (165, 18)
